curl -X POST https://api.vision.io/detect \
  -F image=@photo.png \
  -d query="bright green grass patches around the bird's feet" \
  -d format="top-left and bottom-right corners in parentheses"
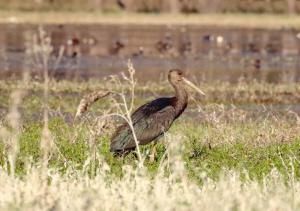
top-left (0, 118), bottom-right (300, 183)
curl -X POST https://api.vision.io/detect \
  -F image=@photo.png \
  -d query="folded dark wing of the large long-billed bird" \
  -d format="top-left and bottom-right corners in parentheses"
top-left (111, 98), bottom-right (175, 151)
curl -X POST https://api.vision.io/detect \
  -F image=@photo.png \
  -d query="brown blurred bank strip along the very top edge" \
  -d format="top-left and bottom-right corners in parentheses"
top-left (0, 0), bottom-right (300, 14)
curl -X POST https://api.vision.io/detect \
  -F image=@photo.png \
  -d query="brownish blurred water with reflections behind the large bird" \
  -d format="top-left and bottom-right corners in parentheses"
top-left (0, 24), bottom-right (300, 82)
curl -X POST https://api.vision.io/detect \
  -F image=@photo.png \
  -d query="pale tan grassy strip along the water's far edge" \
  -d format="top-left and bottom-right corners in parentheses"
top-left (0, 10), bottom-right (300, 29)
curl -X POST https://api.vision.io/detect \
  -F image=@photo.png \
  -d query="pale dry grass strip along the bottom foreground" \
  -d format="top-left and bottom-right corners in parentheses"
top-left (0, 157), bottom-right (300, 211)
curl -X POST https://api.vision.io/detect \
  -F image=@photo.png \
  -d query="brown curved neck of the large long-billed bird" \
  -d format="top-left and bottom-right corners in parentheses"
top-left (172, 83), bottom-right (188, 117)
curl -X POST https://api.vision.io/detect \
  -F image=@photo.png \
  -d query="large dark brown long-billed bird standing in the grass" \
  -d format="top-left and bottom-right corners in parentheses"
top-left (110, 69), bottom-right (205, 155)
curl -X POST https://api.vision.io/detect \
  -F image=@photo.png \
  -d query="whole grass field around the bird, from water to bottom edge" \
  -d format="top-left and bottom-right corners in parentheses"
top-left (0, 71), bottom-right (300, 210)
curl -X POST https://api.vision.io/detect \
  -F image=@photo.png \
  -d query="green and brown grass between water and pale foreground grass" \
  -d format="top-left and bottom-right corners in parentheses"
top-left (0, 81), bottom-right (300, 183)
